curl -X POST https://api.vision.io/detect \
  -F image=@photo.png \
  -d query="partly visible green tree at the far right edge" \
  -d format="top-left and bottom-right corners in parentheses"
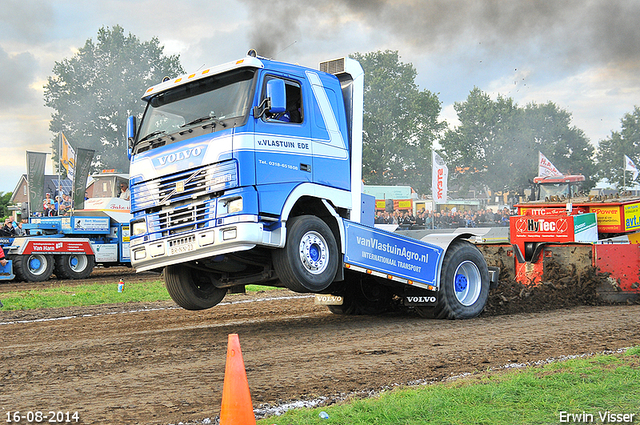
top-left (598, 106), bottom-right (640, 189)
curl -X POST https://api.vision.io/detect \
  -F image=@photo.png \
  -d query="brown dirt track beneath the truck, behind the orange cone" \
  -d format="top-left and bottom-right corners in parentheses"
top-left (0, 284), bottom-right (640, 424)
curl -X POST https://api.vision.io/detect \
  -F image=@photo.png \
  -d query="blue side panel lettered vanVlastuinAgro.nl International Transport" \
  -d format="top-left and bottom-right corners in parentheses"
top-left (344, 220), bottom-right (444, 286)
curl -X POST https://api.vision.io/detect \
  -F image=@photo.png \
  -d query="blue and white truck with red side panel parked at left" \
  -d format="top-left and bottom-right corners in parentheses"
top-left (0, 171), bottom-right (131, 282)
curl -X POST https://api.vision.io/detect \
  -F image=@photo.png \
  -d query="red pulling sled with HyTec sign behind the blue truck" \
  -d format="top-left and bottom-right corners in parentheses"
top-left (478, 175), bottom-right (640, 303)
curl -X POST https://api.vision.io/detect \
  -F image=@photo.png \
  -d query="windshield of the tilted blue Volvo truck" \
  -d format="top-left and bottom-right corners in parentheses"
top-left (136, 68), bottom-right (255, 150)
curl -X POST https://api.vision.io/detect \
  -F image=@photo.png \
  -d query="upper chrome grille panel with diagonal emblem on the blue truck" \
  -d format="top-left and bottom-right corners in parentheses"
top-left (131, 160), bottom-right (238, 211)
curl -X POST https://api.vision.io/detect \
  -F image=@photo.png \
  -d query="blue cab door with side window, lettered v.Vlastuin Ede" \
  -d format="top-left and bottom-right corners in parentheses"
top-left (255, 74), bottom-right (312, 185)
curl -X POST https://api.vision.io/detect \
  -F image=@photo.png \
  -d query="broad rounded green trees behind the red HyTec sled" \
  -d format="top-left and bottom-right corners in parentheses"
top-left (441, 88), bottom-right (595, 193)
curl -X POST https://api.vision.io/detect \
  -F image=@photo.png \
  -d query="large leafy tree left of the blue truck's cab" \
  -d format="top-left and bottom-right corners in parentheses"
top-left (44, 25), bottom-right (184, 172)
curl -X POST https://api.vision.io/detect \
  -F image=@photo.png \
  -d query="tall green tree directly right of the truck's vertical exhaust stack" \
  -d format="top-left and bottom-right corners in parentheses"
top-left (352, 50), bottom-right (445, 193)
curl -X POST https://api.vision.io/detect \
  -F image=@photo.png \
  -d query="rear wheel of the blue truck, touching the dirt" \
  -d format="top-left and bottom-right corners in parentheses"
top-left (430, 241), bottom-right (489, 319)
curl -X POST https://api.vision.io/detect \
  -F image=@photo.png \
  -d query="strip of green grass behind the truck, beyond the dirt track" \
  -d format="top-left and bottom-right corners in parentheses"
top-left (0, 280), bottom-right (279, 311)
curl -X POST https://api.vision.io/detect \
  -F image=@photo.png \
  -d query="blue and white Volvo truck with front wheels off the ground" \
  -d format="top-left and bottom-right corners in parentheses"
top-left (127, 51), bottom-right (499, 318)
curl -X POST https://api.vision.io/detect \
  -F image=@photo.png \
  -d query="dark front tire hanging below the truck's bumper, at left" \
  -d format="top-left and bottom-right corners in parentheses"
top-left (164, 265), bottom-right (227, 310)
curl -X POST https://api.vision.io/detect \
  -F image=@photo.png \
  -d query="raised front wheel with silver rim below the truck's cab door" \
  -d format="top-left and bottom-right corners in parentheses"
top-left (273, 215), bottom-right (339, 292)
